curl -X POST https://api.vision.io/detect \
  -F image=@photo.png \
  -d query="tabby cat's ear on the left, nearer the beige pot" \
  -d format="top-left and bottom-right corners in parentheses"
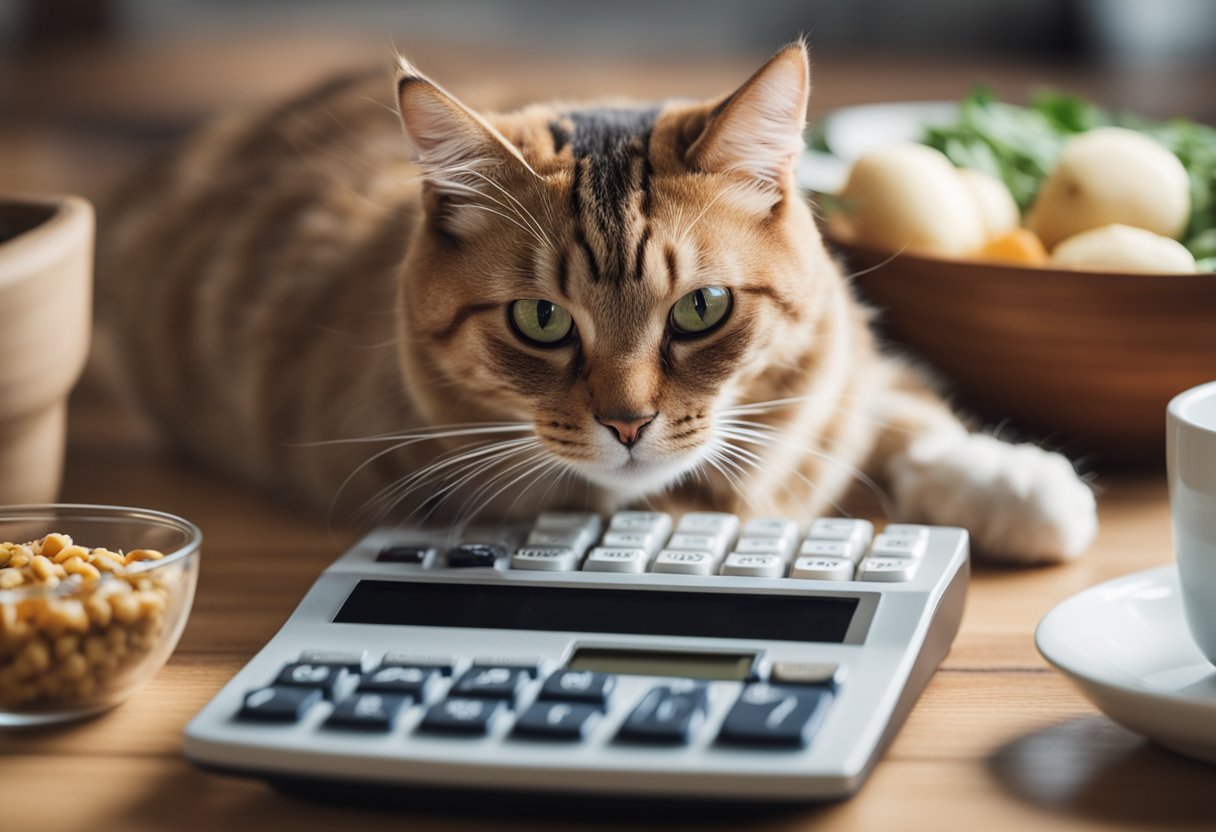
top-left (396, 58), bottom-right (536, 237)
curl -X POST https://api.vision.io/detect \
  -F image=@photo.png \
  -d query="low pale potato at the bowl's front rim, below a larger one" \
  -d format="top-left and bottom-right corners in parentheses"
top-left (1051, 224), bottom-right (1195, 272)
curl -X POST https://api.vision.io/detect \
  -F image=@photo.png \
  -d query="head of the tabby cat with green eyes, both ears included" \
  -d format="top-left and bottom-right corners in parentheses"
top-left (399, 43), bottom-right (839, 497)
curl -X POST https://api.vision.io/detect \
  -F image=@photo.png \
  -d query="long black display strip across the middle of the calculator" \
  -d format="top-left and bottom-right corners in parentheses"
top-left (333, 580), bottom-right (860, 645)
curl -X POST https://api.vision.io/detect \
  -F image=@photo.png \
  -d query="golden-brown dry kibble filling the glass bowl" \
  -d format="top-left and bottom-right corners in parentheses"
top-left (0, 534), bottom-right (180, 708)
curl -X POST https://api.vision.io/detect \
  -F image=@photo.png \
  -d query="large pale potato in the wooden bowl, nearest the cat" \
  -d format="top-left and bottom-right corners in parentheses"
top-left (837, 144), bottom-right (985, 255)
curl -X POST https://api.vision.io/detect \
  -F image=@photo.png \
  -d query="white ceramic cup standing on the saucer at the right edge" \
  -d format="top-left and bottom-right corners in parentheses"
top-left (1165, 381), bottom-right (1216, 664)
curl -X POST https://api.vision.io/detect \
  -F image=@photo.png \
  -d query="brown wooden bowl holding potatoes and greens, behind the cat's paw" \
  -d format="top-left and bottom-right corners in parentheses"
top-left (834, 242), bottom-right (1216, 467)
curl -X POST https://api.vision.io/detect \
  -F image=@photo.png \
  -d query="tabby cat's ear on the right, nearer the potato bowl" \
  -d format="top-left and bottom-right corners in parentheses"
top-left (685, 40), bottom-right (811, 190)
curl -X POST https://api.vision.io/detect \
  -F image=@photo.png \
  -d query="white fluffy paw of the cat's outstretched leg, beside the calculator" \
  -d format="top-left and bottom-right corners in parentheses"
top-left (889, 433), bottom-right (1098, 563)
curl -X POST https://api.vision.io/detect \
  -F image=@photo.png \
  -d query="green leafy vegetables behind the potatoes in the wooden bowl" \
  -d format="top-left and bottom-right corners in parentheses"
top-left (922, 86), bottom-right (1216, 270)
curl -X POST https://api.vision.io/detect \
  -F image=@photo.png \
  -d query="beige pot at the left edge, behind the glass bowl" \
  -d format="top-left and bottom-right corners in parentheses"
top-left (0, 193), bottom-right (94, 505)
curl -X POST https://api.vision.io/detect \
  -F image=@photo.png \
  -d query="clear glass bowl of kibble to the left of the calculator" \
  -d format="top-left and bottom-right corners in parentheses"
top-left (0, 505), bottom-right (203, 726)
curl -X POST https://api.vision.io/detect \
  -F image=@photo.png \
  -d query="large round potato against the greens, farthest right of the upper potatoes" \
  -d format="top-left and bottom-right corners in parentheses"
top-left (1026, 128), bottom-right (1190, 248)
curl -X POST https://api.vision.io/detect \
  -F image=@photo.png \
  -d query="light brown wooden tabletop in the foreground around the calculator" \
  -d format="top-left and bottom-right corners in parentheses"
top-left (0, 379), bottom-right (1216, 832)
